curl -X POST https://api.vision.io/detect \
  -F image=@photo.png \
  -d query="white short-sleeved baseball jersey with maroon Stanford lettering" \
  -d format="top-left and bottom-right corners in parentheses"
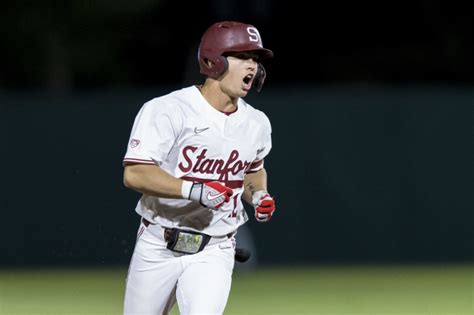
top-left (124, 86), bottom-right (272, 236)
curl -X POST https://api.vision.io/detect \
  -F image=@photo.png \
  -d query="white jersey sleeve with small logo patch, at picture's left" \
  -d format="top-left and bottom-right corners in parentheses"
top-left (123, 100), bottom-right (180, 165)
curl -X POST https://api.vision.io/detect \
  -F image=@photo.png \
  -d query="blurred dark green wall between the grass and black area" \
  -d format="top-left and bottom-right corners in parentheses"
top-left (0, 86), bottom-right (474, 265)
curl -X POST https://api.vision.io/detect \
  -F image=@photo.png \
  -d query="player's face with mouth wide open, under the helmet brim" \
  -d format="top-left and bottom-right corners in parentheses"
top-left (221, 52), bottom-right (258, 97)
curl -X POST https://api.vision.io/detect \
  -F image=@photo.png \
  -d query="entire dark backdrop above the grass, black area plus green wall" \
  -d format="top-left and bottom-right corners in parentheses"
top-left (0, 0), bottom-right (474, 266)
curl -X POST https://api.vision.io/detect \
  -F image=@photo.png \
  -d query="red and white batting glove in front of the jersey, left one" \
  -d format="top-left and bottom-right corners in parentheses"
top-left (181, 181), bottom-right (234, 210)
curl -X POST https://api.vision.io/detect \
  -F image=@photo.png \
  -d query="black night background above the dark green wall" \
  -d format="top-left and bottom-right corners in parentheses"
top-left (0, 0), bottom-right (474, 90)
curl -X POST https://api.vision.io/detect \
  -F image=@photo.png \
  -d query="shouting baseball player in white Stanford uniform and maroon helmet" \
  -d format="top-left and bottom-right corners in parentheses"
top-left (124, 21), bottom-right (275, 314)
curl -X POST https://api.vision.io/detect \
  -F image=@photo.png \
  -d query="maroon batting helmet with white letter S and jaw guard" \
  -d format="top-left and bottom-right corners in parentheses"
top-left (198, 21), bottom-right (273, 92)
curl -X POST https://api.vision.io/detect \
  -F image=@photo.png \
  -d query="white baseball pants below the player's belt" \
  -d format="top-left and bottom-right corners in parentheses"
top-left (124, 222), bottom-right (235, 315)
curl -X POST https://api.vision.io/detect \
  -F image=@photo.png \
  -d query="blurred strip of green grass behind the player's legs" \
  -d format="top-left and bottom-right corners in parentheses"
top-left (0, 265), bottom-right (474, 315)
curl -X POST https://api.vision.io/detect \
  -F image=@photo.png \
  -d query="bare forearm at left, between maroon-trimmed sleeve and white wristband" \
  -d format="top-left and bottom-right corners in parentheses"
top-left (123, 164), bottom-right (183, 198)
